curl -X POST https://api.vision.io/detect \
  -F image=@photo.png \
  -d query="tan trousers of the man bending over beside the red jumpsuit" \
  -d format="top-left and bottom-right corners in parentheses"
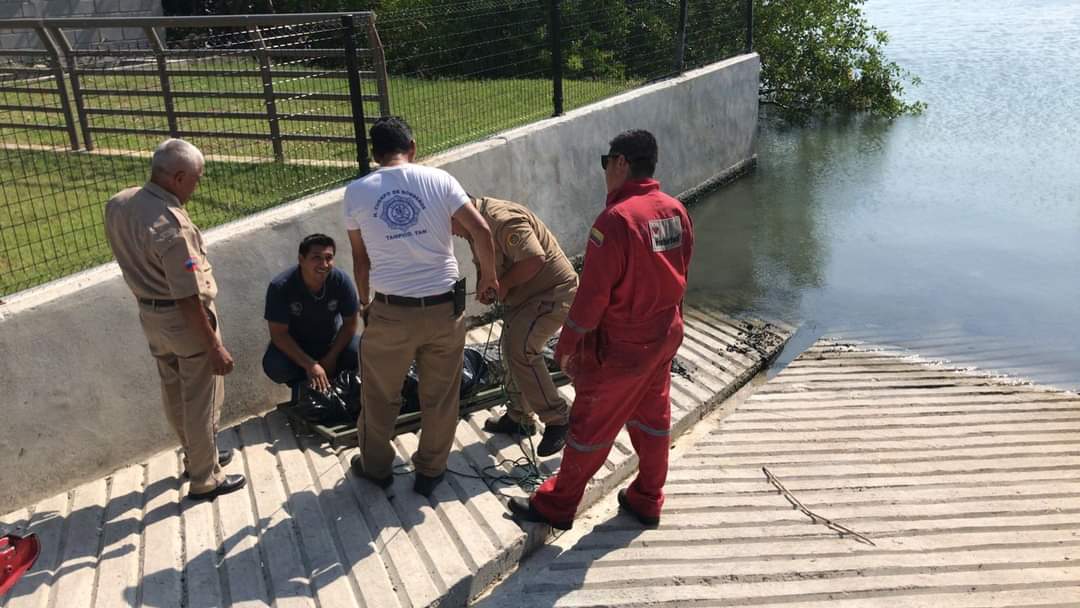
top-left (499, 294), bottom-right (573, 425)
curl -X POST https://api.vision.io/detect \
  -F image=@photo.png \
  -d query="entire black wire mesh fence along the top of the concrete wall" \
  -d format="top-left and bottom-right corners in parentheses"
top-left (0, 0), bottom-right (752, 296)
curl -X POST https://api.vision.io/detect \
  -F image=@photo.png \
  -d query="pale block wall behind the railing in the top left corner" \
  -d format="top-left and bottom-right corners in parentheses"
top-left (0, 0), bottom-right (162, 49)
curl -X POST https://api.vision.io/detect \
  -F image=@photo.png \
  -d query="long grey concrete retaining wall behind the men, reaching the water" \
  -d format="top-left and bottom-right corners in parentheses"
top-left (0, 55), bottom-right (760, 513)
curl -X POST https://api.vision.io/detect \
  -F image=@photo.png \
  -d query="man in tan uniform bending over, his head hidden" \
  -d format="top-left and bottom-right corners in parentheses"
top-left (455, 197), bottom-right (578, 456)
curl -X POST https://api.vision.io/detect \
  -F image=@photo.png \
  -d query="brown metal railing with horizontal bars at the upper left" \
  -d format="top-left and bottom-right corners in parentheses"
top-left (0, 13), bottom-right (389, 161)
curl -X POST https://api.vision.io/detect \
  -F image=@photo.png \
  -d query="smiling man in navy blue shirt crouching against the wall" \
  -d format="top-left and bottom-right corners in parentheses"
top-left (262, 234), bottom-right (360, 398)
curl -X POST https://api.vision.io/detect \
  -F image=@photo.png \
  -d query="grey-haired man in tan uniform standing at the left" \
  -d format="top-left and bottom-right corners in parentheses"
top-left (105, 139), bottom-right (245, 500)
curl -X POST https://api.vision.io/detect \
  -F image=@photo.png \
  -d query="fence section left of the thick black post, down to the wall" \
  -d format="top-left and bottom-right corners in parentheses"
top-left (0, 13), bottom-right (389, 294)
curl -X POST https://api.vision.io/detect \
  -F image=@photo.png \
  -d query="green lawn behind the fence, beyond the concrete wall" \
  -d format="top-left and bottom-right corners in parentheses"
top-left (0, 60), bottom-right (638, 296)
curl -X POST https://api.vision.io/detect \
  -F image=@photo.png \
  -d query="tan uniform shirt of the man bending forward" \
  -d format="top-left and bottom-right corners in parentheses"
top-left (476, 197), bottom-right (578, 308)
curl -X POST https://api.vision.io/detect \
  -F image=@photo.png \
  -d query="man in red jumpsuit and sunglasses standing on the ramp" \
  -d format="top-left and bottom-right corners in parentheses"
top-left (510, 131), bottom-right (693, 530)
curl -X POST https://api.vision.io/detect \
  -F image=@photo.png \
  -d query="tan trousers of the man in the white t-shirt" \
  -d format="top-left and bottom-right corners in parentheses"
top-left (356, 300), bottom-right (465, 477)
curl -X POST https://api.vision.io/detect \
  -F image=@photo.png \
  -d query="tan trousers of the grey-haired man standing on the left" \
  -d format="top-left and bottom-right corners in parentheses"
top-left (139, 305), bottom-right (225, 492)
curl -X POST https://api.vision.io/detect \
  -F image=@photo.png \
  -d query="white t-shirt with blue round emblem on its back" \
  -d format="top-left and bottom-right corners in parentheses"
top-left (345, 164), bottom-right (469, 298)
